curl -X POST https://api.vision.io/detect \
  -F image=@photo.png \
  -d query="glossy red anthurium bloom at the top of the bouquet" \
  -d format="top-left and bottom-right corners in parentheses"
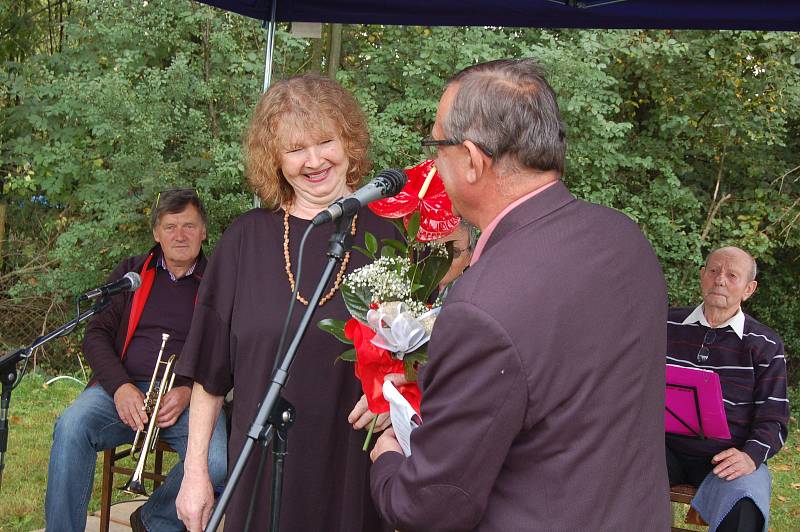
top-left (369, 160), bottom-right (460, 242)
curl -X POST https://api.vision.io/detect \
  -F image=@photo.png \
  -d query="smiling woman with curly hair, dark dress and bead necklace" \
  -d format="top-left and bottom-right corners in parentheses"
top-left (177, 76), bottom-right (395, 532)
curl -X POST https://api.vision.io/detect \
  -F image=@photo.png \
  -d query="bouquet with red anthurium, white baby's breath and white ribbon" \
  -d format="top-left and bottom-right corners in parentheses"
top-left (319, 161), bottom-right (460, 449)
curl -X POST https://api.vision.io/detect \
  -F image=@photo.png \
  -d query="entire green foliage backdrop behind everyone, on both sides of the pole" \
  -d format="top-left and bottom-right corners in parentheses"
top-left (0, 0), bottom-right (800, 382)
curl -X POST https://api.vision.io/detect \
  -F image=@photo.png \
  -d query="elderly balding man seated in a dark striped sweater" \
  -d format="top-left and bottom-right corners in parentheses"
top-left (666, 247), bottom-right (789, 532)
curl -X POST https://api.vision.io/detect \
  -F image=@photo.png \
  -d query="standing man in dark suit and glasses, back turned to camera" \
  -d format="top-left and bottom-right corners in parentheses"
top-left (371, 59), bottom-right (670, 532)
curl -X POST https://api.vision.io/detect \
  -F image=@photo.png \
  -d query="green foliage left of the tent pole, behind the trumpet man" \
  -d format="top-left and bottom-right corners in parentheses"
top-left (0, 1), bottom-right (261, 358)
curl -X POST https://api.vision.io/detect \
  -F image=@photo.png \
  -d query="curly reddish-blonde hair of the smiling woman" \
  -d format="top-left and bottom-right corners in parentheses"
top-left (244, 74), bottom-right (372, 209)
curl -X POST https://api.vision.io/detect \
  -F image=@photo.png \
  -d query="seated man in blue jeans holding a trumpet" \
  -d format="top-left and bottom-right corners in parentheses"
top-left (45, 189), bottom-right (227, 532)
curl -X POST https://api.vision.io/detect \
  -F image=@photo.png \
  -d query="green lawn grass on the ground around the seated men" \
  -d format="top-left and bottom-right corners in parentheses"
top-left (0, 375), bottom-right (800, 532)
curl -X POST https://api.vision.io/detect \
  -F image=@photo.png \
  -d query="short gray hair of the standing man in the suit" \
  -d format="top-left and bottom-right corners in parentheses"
top-left (442, 59), bottom-right (567, 175)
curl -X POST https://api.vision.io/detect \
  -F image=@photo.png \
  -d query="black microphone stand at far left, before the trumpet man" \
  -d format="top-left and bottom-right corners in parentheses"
top-left (0, 297), bottom-right (111, 489)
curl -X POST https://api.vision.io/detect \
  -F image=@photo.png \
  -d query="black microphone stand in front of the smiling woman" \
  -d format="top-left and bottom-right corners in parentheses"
top-left (205, 214), bottom-right (353, 532)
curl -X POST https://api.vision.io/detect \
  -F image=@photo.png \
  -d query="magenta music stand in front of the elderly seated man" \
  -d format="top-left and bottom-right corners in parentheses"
top-left (664, 364), bottom-right (731, 440)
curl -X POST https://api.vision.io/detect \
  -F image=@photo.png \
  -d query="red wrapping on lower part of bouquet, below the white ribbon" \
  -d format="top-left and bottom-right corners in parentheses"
top-left (344, 318), bottom-right (422, 414)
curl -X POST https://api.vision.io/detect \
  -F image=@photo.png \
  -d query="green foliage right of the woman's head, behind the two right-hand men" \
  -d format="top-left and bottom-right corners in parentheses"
top-left (339, 26), bottom-right (800, 382)
